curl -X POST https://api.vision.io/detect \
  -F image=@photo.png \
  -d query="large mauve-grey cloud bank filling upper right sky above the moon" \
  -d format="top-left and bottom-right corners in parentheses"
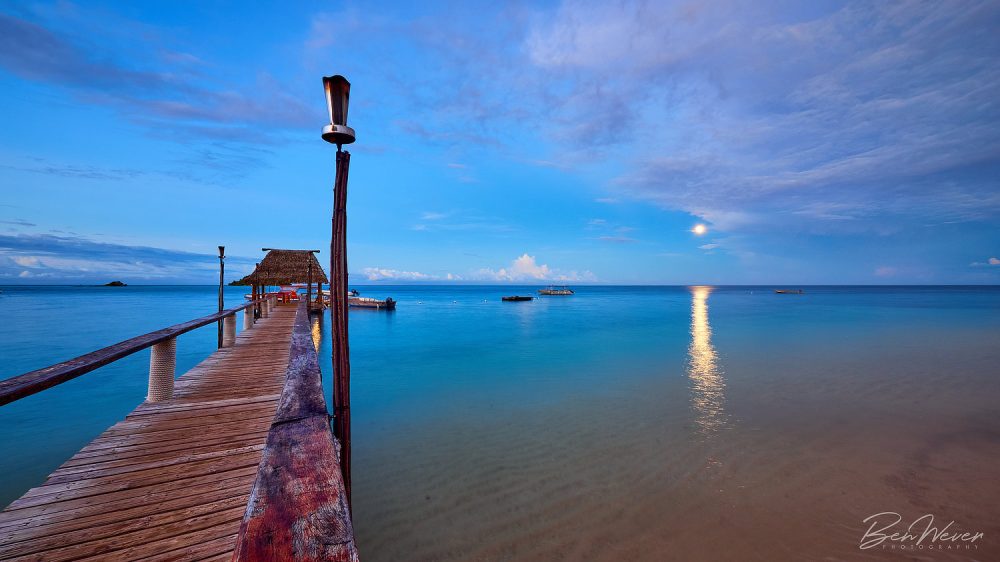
top-left (525, 1), bottom-right (1000, 229)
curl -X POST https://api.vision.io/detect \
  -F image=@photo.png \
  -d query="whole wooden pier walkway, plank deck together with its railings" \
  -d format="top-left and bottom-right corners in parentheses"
top-left (0, 302), bottom-right (357, 561)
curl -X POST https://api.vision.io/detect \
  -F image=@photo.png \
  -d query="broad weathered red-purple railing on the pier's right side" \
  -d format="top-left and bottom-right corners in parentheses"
top-left (233, 303), bottom-right (358, 561)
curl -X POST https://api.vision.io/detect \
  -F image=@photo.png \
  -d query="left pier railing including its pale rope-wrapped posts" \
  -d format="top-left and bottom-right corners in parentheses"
top-left (0, 295), bottom-right (275, 406)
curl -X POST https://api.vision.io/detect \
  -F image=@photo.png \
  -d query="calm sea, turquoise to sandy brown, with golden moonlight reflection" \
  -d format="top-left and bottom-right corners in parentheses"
top-left (0, 286), bottom-right (1000, 560)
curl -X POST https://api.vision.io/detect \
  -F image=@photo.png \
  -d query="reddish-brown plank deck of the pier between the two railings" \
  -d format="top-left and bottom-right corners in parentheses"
top-left (0, 305), bottom-right (296, 561)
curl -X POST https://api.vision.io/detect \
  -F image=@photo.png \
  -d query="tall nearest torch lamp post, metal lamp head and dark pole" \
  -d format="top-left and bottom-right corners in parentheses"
top-left (323, 75), bottom-right (354, 507)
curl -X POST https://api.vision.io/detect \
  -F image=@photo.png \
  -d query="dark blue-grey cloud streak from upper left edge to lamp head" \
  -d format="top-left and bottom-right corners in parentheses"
top-left (0, 12), bottom-right (320, 143)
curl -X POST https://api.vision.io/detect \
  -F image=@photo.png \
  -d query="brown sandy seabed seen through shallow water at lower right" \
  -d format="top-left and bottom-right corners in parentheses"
top-left (354, 334), bottom-right (1000, 560)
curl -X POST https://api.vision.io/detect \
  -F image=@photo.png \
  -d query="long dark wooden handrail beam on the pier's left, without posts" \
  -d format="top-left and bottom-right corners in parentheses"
top-left (0, 297), bottom-right (272, 406)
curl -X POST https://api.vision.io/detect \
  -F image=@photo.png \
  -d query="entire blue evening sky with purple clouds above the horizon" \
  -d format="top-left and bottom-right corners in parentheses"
top-left (0, 1), bottom-right (1000, 284)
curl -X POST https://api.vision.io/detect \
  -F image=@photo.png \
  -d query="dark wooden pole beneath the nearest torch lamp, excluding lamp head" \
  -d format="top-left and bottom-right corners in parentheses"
top-left (330, 146), bottom-right (351, 505)
